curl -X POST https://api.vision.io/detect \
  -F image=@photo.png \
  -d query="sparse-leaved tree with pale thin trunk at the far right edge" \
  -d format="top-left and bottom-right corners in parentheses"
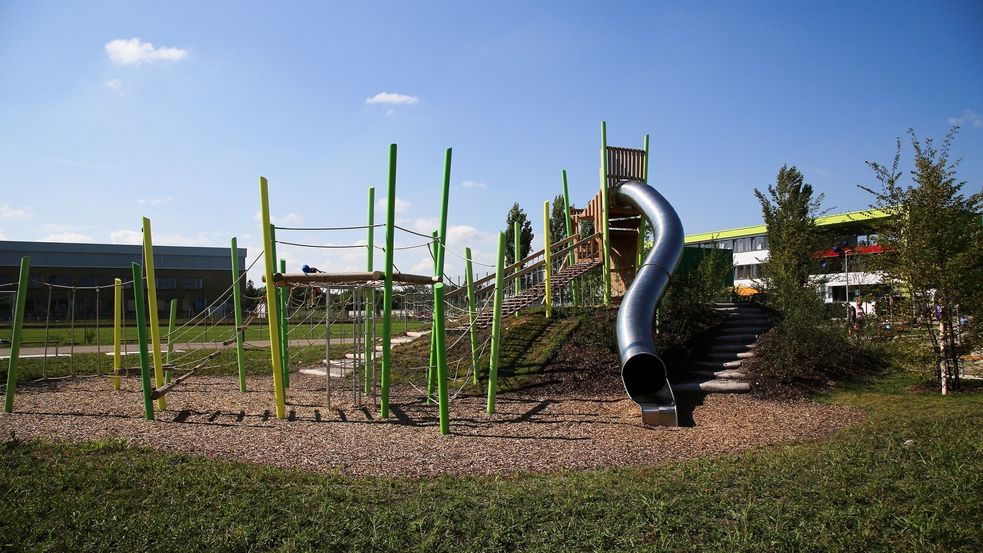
top-left (860, 127), bottom-right (983, 394)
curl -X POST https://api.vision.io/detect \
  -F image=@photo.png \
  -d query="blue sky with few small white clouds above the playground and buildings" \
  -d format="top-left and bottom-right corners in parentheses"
top-left (0, 1), bottom-right (983, 274)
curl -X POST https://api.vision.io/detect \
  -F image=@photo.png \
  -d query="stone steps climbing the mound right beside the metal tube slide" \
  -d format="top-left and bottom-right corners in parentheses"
top-left (673, 303), bottom-right (771, 393)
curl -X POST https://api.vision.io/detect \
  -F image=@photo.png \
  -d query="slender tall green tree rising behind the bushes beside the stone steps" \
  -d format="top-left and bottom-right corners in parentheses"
top-left (754, 165), bottom-right (823, 316)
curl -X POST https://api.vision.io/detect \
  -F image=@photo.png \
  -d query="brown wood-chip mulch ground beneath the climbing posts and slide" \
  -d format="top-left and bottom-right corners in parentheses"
top-left (0, 374), bottom-right (863, 477)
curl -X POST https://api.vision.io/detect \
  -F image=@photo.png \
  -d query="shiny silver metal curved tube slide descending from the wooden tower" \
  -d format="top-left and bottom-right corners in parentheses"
top-left (613, 181), bottom-right (683, 426)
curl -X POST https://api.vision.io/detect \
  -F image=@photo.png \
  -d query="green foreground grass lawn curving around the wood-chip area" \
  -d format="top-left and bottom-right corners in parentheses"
top-left (0, 375), bottom-right (983, 551)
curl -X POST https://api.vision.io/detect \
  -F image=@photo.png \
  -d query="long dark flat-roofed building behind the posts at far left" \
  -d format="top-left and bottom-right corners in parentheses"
top-left (0, 241), bottom-right (246, 321)
